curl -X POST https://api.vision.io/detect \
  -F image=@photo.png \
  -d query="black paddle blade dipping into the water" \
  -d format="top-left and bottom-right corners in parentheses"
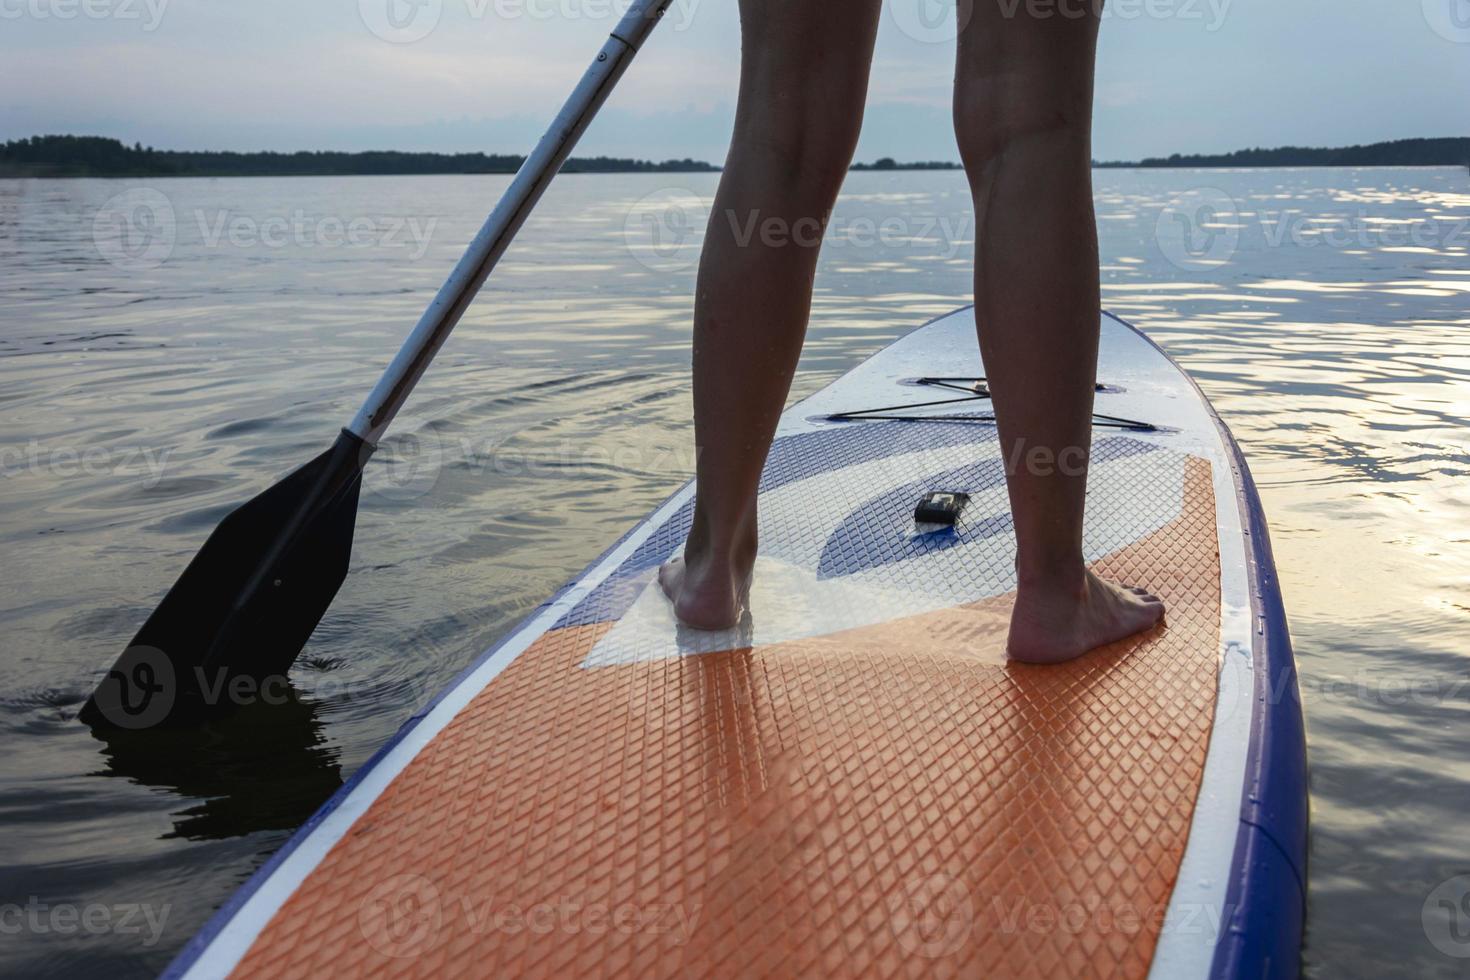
top-left (81, 429), bottom-right (372, 729)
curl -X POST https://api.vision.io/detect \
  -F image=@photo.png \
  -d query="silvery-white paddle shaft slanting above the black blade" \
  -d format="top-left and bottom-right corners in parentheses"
top-left (347, 0), bottom-right (670, 445)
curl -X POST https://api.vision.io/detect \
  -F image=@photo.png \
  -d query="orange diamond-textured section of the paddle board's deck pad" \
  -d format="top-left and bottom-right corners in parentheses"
top-left (226, 431), bottom-right (1223, 977)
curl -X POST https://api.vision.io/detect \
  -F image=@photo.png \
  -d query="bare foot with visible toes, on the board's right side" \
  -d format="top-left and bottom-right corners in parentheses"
top-left (1005, 569), bottom-right (1164, 664)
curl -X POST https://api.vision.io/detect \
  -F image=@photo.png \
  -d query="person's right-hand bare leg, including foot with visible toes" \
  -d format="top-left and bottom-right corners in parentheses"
top-left (954, 0), bottom-right (1164, 663)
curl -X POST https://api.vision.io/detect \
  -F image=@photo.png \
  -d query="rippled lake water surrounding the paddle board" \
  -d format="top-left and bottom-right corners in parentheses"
top-left (0, 169), bottom-right (1470, 977)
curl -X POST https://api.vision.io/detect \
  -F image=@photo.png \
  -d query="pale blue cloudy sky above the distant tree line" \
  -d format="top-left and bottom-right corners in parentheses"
top-left (0, 0), bottom-right (1470, 163)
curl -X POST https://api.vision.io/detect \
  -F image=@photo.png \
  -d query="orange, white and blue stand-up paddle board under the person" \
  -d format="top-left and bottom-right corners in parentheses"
top-left (169, 310), bottom-right (1305, 979)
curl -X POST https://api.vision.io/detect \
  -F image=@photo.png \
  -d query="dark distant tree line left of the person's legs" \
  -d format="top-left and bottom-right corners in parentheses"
top-left (0, 137), bottom-right (719, 176)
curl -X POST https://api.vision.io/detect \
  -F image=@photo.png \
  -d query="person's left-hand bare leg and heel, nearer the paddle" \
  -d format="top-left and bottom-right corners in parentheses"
top-left (659, 0), bottom-right (881, 629)
